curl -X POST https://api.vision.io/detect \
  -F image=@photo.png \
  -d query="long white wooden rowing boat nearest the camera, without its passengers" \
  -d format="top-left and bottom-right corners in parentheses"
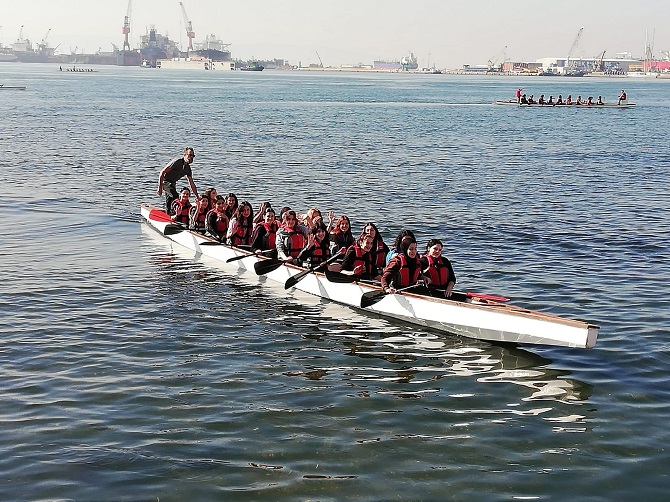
top-left (141, 206), bottom-right (600, 349)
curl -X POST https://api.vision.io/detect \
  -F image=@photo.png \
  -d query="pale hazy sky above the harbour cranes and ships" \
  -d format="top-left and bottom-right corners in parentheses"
top-left (0, 0), bottom-right (670, 68)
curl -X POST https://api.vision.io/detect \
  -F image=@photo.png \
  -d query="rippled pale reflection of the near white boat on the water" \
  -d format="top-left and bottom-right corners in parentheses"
top-left (142, 225), bottom-right (592, 416)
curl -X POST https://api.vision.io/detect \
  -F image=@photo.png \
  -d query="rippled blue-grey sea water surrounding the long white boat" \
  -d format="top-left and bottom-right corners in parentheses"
top-left (0, 63), bottom-right (670, 501)
